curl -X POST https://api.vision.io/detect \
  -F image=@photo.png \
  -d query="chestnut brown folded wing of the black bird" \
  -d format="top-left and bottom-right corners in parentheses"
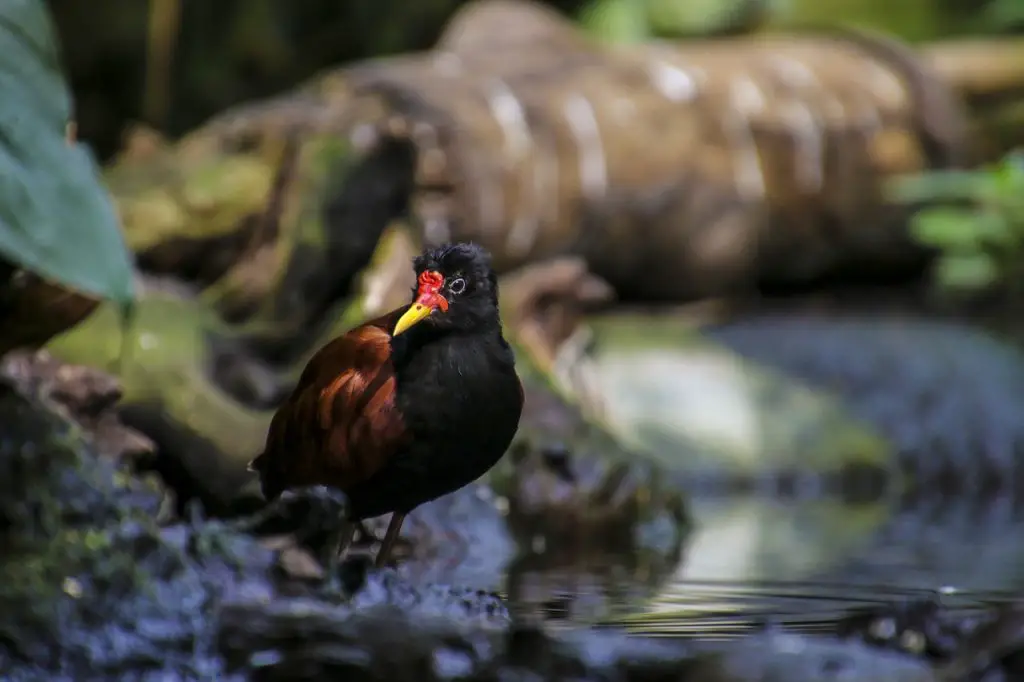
top-left (250, 311), bottom-right (407, 499)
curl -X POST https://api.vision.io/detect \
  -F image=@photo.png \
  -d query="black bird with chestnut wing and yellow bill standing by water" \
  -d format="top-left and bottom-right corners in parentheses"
top-left (249, 244), bottom-right (523, 576)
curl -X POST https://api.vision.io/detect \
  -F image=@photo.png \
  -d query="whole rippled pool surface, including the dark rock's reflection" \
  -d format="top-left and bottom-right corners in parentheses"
top-left (402, 485), bottom-right (1024, 637)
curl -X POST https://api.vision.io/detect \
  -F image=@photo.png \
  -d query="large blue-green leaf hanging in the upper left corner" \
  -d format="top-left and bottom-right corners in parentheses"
top-left (0, 0), bottom-right (134, 305)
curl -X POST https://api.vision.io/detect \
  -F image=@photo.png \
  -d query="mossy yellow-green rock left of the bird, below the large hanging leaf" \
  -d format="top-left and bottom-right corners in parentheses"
top-left (49, 291), bottom-right (269, 511)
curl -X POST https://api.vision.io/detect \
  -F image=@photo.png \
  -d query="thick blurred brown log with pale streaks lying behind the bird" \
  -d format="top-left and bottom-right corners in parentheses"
top-left (349, 0), bottom-right (968, 299)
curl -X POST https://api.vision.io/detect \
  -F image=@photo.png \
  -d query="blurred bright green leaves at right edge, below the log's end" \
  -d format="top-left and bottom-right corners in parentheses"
top-left (892, 151), bottom-right (1024, 293)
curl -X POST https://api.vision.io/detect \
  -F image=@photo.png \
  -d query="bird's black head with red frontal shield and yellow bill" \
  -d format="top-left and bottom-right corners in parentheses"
top-left (392, 244), bottom-right (500, 336)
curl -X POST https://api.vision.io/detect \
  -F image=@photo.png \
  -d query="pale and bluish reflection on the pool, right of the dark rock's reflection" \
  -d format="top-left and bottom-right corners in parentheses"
top-left (622, 489), bottom-right (1024, 636)
